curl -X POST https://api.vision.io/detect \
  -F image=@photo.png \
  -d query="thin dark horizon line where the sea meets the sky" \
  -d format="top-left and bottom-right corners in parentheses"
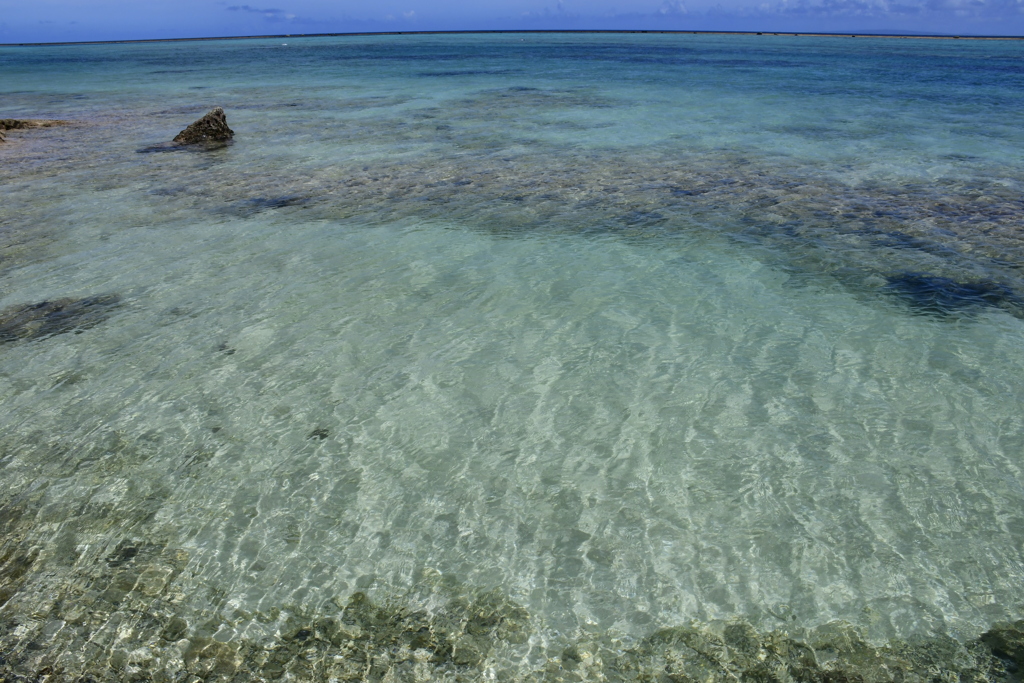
top-left (0, 29), bottom-right (1024, 47)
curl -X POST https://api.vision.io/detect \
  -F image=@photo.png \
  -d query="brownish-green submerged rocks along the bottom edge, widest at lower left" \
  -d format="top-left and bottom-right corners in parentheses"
top-left (0, 491), bottom-right (1024, 683)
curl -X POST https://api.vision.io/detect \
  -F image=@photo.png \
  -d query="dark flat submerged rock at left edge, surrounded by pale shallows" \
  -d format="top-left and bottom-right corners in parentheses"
top-left (0, 294), bottom-right (121, 343)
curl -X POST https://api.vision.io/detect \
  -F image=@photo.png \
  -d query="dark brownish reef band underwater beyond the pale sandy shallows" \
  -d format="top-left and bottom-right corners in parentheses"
top-left (4, 98), bottom-right (1024, 318)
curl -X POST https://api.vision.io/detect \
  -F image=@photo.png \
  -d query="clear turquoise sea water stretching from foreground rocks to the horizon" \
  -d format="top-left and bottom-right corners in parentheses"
top-left (0, 31), bottom-right (1024, 680)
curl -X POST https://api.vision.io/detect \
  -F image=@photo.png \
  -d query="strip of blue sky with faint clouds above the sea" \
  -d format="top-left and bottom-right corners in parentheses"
top-left (0, 0), bottom-right (1024, 43)
